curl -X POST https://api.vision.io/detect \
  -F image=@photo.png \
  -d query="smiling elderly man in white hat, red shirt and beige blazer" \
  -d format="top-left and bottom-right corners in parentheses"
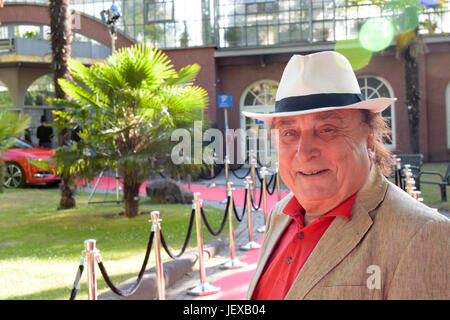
top-left (245, 52), bottom-right (450, 299)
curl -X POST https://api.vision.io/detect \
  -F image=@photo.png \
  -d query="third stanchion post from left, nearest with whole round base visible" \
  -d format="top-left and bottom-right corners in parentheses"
top-left (187, 192), bottom-right (220, 296)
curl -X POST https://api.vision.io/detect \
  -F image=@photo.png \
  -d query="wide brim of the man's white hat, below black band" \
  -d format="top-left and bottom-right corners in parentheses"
top-left (242, 98), bottom-right (397, 122)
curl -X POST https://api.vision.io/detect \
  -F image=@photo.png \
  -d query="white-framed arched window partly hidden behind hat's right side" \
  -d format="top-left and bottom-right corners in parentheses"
top-left (357, 75), bottom-right (396, 150)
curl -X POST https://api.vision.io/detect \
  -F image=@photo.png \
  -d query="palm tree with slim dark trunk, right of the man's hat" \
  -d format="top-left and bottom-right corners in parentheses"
top-left (349, 0), bottom-right (442, 153)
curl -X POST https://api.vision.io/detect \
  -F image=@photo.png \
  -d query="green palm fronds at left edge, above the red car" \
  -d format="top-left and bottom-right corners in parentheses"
top-left (0, 110), bottom-right (31, 193)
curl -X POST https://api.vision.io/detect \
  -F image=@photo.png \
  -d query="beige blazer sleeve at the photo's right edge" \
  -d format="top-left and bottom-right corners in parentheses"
top-left (387, 218), bottom-right (450, 300)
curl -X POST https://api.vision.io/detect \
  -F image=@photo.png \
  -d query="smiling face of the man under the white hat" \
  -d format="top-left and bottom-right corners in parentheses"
top-left (273, 110), bottom-right (372, 214)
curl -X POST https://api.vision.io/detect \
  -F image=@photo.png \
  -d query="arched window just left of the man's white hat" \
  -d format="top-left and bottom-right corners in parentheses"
top-left (240, 79), bottom-right (278, 164)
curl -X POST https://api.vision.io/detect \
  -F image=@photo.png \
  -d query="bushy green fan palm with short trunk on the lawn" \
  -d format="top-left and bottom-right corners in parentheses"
top-left (53, 45), bottom-right (207, 217)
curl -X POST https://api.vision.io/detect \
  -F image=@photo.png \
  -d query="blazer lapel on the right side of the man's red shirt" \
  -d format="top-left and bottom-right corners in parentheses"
top-left (285, 166), bottom-right (387, 299)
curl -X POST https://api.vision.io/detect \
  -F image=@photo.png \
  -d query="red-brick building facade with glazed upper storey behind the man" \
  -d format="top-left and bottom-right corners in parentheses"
top-left (0, 0), bottom-right (450, 161)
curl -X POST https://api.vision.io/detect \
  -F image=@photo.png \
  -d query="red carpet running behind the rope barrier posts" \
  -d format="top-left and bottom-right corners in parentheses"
top-left (78, 177), bottom-right (288, 300)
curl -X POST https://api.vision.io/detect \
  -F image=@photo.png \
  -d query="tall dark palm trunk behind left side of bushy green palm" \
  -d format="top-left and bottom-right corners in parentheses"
top-left (48, 0), bottom-right (76, 209)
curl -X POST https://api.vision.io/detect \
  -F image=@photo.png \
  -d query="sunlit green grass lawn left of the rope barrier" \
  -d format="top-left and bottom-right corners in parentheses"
top-left (0, 187), bottom-right (227, 300)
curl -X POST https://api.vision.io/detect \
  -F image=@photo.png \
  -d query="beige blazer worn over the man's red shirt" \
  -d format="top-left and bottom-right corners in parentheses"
top-left (247, 166), bottom-right (450, 299)
